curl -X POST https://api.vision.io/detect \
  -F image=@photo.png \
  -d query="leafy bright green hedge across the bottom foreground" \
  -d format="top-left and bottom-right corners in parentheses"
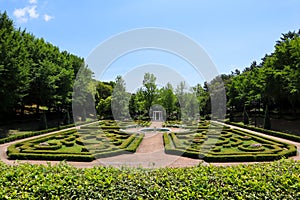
top-left (0, 160), bottom-right (300, 199)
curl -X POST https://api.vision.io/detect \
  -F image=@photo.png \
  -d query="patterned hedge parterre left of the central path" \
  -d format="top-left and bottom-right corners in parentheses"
top-left (8, 121), bottom-right (144, 161)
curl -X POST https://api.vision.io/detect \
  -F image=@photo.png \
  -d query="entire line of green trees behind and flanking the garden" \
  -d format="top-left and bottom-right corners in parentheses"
top-left (0, 12), bottom-right (300, 125)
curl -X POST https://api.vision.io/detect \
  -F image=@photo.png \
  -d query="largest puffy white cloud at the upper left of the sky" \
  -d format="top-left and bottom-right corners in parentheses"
top-left (13, 6), bottom-right (39, 23)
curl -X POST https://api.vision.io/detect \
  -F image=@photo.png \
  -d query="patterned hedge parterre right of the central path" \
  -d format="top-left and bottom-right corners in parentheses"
top-left (163, 125), bottom-right (297, 162)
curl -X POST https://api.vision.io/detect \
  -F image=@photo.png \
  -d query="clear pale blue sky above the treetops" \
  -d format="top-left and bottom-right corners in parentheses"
top-left (0, 0), bottom-right (300, 85)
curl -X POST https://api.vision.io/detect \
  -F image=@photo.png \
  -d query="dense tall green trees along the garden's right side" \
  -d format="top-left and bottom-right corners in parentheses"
top-left (225, 31), bottom-right (300, 117)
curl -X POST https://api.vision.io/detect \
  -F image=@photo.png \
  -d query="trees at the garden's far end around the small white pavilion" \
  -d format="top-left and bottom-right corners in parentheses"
top-left (95, 73), bottom-right (210, 120)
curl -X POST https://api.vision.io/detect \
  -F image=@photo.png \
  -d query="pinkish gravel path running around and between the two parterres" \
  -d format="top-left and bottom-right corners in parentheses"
top-left (0, 122), bottom-right (300, 168)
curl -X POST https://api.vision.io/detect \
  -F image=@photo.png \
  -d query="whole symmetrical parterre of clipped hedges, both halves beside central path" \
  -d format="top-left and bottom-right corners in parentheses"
top-left (7, 120), bottom-right (297, 162)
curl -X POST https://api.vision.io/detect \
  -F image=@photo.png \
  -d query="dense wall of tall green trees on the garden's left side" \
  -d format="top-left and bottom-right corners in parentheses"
top-left (0, 12), bottom-right (84, 120)
